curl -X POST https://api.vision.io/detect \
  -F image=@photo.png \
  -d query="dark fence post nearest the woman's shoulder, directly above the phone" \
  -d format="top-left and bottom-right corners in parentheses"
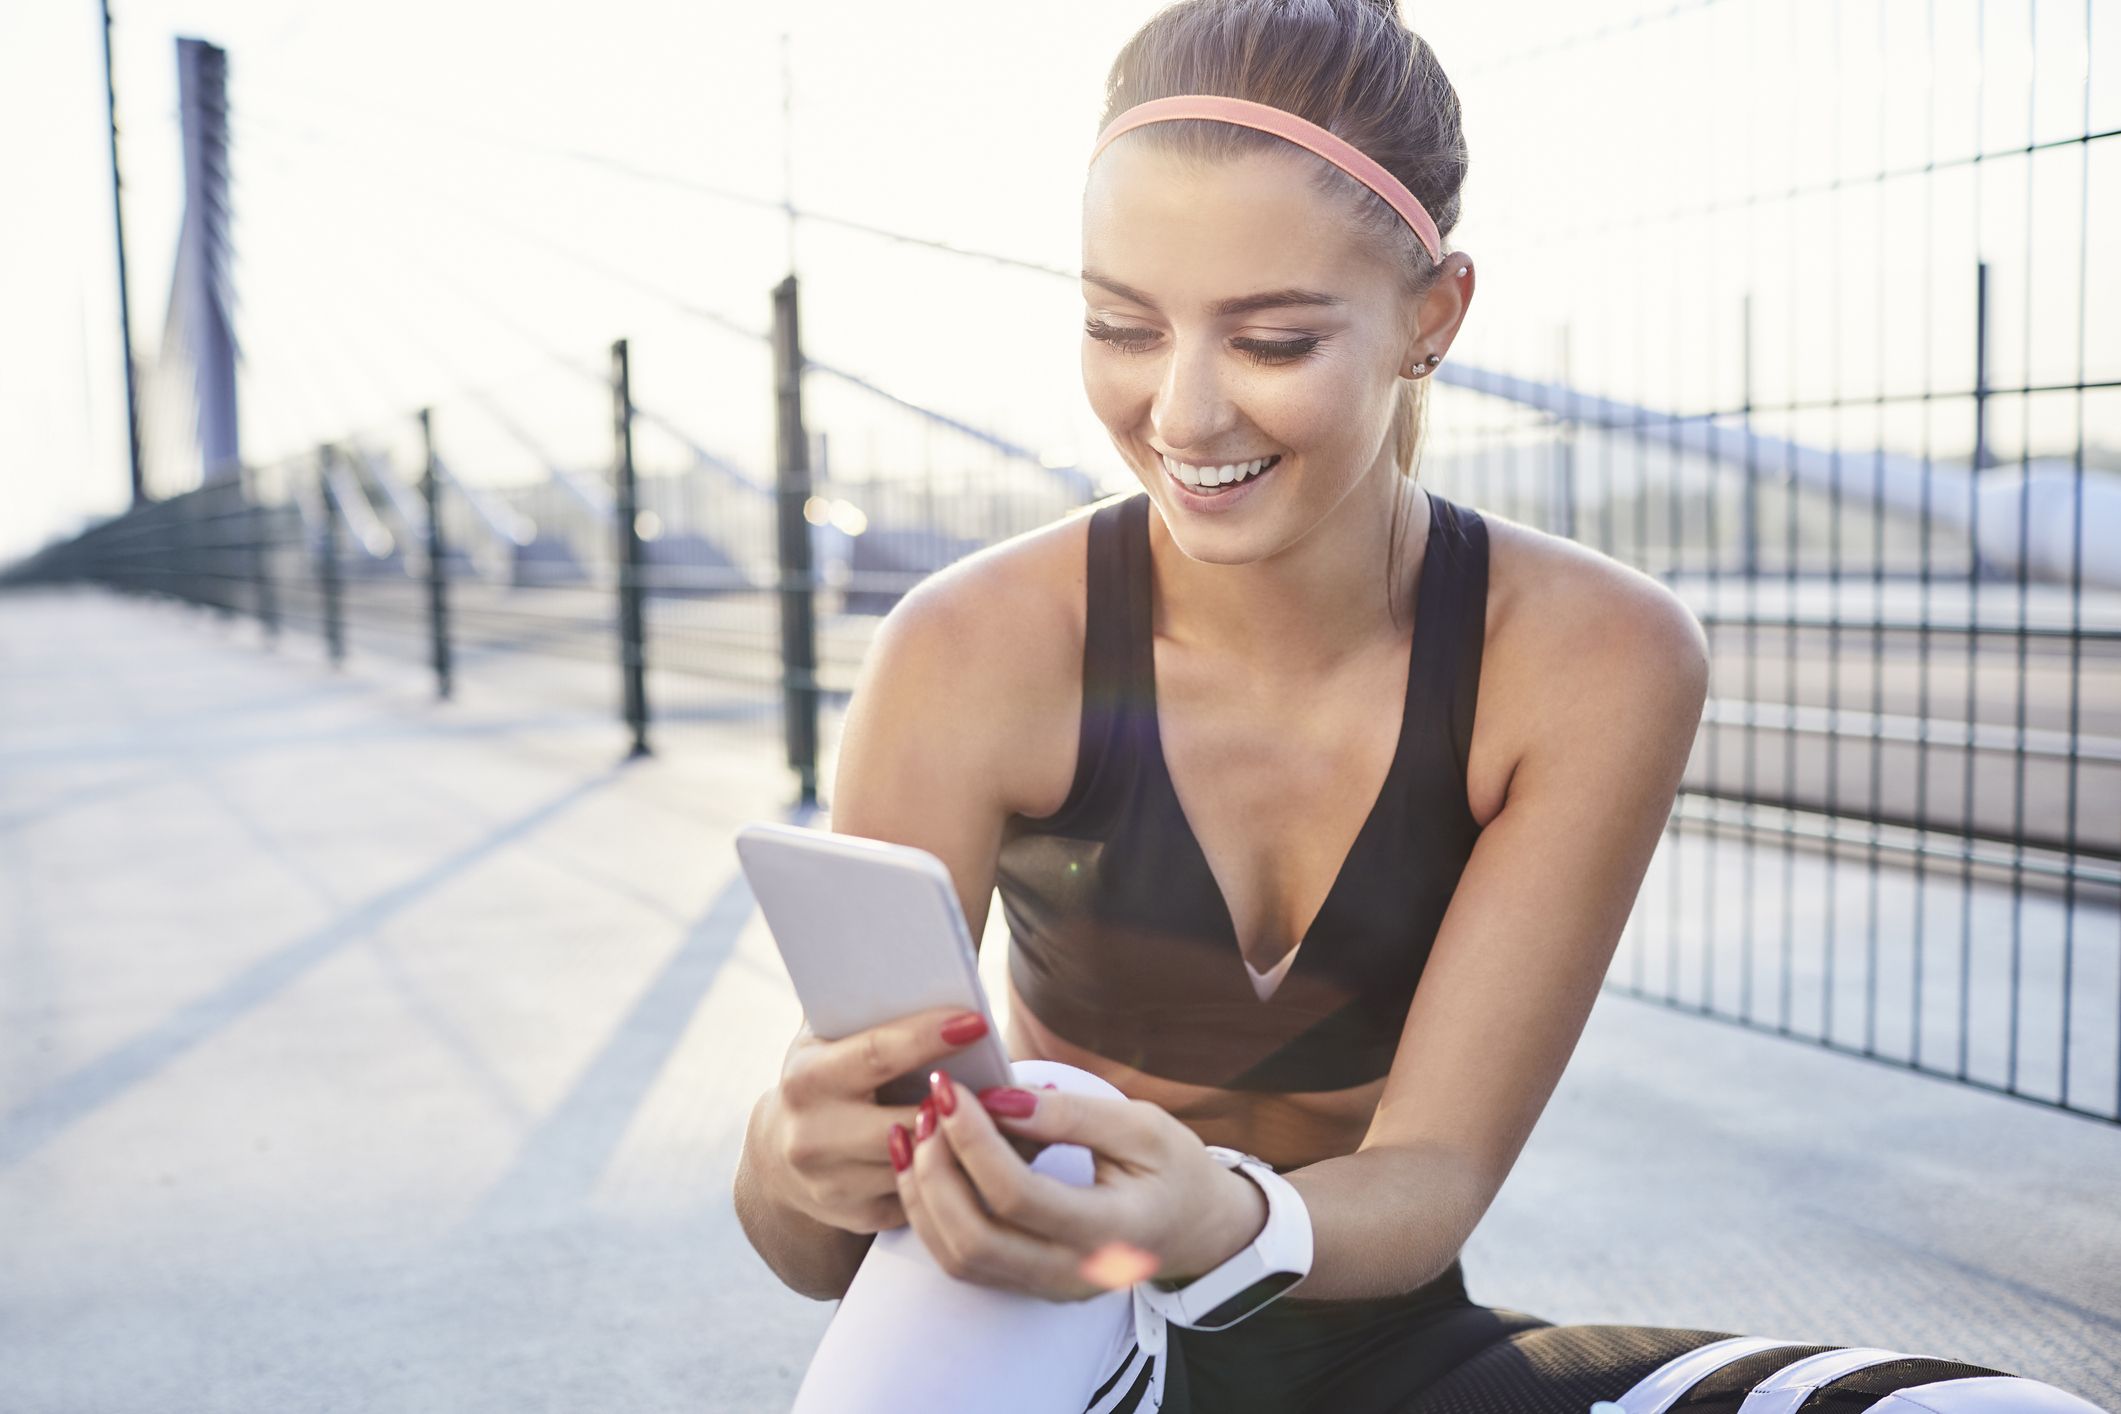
top-left (774, 276), bottom-right (817, 806)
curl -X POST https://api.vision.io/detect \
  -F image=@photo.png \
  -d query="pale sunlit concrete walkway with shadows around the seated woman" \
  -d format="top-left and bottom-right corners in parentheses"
top-left (0, 591), bottom-right (2121, 1414)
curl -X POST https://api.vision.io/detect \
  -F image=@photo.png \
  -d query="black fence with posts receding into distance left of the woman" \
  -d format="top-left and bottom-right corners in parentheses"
top-left (4, 307), bottom-right (1097, 799)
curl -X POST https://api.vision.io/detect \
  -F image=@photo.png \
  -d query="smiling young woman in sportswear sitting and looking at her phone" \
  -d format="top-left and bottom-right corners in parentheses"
top-left (736, 0), bottom-right (2091, 1414)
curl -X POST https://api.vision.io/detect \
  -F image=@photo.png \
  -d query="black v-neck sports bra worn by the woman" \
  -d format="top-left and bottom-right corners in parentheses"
top-left (997, 488), bottom-right (1487, 1092)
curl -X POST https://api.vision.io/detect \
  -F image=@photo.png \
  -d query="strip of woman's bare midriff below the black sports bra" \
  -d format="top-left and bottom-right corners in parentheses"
top-left (1005, 977), bottom-right (1385, 1168)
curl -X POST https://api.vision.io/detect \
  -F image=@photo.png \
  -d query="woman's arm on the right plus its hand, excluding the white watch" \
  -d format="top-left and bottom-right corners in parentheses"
top-left (899, 576), bottom-right (1707, 1300)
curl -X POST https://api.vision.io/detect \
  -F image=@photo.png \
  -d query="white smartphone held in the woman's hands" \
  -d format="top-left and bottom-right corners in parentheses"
top-left (736, 823), bottom-right (1012, 1104)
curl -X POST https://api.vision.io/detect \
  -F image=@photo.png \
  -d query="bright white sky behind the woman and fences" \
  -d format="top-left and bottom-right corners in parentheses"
top-left (0, 0), bottom-right (2121, 558)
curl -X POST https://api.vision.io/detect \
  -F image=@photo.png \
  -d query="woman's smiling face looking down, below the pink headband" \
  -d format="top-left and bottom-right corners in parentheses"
top-left (1082, 142), bottom-right (1417, 564)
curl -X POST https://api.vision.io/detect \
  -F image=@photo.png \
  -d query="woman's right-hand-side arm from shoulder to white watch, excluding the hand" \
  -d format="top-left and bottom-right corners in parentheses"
top-left (1287, 572), bottom-right (1710, 1300)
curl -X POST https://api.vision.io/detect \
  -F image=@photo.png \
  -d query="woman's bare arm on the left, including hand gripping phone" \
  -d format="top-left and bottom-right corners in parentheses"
top-left (734, 551), bottom-right (1073, 1302)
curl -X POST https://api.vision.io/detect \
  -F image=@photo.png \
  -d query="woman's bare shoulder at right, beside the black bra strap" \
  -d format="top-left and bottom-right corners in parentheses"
top-left (1476, 511), bottom-right (1707, 820)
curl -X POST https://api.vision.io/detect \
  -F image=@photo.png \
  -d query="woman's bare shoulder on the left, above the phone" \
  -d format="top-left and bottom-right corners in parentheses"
top-left (851, 507), bottom-right (1094, 814)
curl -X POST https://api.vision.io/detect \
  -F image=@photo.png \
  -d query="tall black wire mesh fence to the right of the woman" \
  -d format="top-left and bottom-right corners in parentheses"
top-left (1432, 0), bottom-right (2121, 1119)
